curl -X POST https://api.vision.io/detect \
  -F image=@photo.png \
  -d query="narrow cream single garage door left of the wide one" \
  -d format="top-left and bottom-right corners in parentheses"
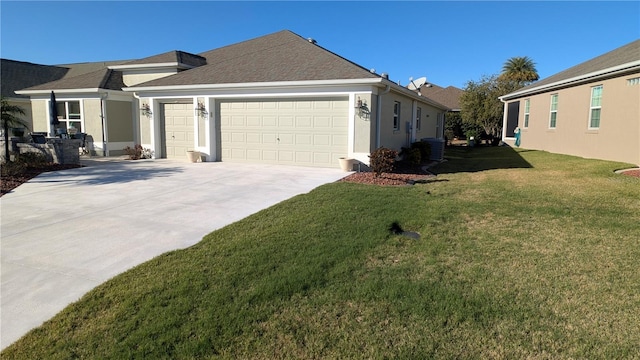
top-left (162, 103), bottom-right (194, 159)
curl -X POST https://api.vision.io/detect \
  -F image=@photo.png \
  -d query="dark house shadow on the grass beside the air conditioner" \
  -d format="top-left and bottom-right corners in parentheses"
top-left (430, 146), bottom-right (534, 175)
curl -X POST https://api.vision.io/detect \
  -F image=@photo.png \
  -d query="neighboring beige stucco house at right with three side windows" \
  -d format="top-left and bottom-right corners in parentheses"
top-left (500, 40), bottom-right (640, 165)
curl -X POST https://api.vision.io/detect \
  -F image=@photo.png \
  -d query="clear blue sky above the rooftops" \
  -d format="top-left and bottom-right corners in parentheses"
top-left (0, 0), bottom-right (640, 88)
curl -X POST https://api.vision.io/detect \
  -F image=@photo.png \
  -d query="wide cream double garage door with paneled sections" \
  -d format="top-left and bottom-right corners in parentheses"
top-left (219, 97), bottom-right (349, 167)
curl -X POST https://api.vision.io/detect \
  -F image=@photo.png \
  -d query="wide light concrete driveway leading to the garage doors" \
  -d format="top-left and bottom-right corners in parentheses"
top-left (0, 160), bottom-right (348, 349)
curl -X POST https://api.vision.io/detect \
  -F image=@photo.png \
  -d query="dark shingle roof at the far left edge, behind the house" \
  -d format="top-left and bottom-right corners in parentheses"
top-left (0, 59), bottom-right (69, 98)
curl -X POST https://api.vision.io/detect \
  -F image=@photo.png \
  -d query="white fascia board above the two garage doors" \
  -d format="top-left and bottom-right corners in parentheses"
top-left (123, 78), bottom-right (381, 92)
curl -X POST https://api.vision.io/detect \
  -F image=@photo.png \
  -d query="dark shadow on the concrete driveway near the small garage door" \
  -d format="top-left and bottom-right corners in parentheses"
top-left (31, 160), bottom-right (182, 185)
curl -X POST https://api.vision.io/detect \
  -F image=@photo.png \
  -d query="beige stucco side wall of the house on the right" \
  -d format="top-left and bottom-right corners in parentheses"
top-left (510, 74), bottom-right (640, 164)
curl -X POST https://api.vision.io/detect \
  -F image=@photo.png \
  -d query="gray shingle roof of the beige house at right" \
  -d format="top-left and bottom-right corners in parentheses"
top-left (503, 39), bottom-right (640, 97)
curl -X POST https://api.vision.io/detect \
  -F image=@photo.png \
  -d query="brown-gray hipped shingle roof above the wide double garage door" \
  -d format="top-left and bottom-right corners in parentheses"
top-left (136, 30), bottom-right (379, 87)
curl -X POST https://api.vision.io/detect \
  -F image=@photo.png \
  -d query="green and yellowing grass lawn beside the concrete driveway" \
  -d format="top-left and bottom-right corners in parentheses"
top-left (2, 147), bottom-right (640, 359)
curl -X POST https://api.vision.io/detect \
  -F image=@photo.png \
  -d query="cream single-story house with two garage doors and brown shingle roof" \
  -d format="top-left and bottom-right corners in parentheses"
top-left (11, 30), bottom-right (449, 167)
